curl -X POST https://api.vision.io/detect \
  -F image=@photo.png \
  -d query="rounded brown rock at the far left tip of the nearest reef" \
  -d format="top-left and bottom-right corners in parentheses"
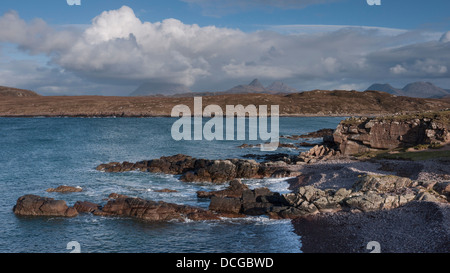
top-left (13, 195), bottom-right (78, 217)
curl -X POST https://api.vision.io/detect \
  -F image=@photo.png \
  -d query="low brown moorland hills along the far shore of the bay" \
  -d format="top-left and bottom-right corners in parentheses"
top-left (0, 90), bottom-right (450, 117)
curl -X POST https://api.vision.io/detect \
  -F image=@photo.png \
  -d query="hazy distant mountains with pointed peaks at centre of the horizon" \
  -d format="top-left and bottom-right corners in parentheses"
top-left (130, 79), bottom-right (299, 97)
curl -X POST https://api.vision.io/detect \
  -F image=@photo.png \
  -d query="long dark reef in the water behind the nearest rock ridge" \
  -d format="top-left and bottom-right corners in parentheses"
top-left (97, 154), bottom-right (296, 183)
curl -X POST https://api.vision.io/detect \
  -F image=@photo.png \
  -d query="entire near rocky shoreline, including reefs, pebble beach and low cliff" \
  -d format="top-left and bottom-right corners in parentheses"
top-left (13, 113), bottom-right (450, 252)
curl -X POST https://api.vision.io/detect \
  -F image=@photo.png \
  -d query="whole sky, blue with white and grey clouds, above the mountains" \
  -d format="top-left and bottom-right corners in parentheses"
top-left (0, 0), bottom-right (450, 95)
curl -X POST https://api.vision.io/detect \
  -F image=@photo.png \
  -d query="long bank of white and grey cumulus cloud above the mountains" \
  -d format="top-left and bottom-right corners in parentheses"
top-left (0, 5), bottom-right (450, 95)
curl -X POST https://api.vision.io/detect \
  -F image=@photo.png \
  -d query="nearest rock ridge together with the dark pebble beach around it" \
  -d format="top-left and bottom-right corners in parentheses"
top-left (14, 154), bottom-right (450, 253)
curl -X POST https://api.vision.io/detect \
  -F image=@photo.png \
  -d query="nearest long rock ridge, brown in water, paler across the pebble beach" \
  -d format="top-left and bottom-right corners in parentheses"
top-left (13, 175), bottom-right (450, 221)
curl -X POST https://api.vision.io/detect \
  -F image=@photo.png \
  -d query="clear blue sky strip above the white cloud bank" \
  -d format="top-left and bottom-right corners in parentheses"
top-left (0, 0), bottom-right (450, 31)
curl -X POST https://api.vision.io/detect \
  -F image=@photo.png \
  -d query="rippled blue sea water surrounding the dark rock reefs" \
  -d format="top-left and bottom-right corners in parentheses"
top-left (0, 118), bottom-right (342, 253)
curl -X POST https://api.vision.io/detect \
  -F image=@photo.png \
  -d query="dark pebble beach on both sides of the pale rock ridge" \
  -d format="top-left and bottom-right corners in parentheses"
top-left (290, 156), bottom-right (450, 253)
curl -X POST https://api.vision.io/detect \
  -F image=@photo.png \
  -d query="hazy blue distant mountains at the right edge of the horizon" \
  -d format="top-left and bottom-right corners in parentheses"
top-left (366, 82), bottom-right (450, 98)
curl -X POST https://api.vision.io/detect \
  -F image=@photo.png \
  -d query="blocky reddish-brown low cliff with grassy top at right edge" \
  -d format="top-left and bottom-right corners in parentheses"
top-left (333, 111), bottom-right (450, 155)
